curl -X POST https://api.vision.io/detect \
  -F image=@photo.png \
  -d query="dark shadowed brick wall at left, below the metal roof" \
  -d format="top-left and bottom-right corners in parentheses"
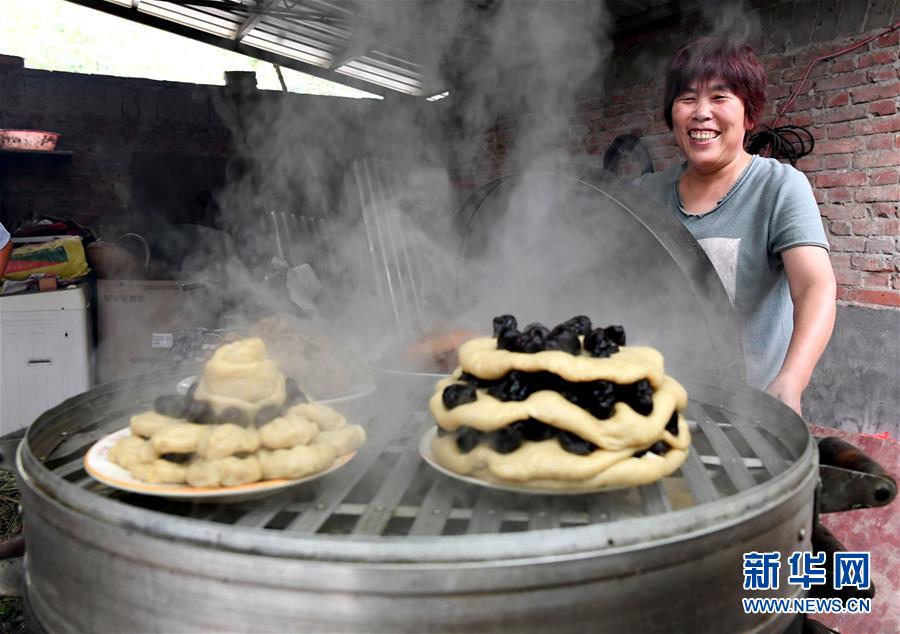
top-left (0, 60), bottom-right (372, 239)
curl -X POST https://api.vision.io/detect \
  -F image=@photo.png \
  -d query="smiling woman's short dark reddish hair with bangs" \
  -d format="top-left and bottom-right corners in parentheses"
top-left (663, 37), bottom-right (766, 130)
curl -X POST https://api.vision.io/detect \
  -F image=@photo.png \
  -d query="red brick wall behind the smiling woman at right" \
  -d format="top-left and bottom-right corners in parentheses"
top-left (458, 0), bottom-right (900, 308)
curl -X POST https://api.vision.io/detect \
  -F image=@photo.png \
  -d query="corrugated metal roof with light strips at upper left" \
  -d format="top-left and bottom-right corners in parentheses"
top-left (63, 0), bottom-right (678, 98)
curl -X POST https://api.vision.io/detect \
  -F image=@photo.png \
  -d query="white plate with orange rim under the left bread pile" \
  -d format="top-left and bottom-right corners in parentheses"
top-left (84, 427), bottom-right (356, 502)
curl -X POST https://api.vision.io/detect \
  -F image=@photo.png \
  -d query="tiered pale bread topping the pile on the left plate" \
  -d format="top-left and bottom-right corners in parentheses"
top-left (194, 338), bottom-right (286, 420)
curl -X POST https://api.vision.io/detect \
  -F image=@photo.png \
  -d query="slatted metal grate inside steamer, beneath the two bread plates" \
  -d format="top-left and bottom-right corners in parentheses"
top-left (22, 360), bottom-right (814, 545)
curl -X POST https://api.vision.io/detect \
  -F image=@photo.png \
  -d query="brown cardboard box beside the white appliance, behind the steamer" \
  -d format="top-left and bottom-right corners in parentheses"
top-left (97, 280), bottom-right (222, 383)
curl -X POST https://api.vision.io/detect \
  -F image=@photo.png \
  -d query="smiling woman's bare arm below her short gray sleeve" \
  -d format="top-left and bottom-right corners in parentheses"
top-left (766, 246), bottom-right (836, 414)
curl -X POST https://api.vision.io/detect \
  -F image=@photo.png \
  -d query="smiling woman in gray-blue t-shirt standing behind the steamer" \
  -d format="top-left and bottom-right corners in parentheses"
top-left (639, 38), bottom-right (835, 412)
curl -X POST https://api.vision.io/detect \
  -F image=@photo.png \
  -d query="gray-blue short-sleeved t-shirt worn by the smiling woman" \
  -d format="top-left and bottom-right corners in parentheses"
top-left (635, 156), bottom-right (828, 388)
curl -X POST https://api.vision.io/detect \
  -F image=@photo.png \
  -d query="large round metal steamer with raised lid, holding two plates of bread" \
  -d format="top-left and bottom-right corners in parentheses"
top-left (18, 170), bottom-right (818, 633)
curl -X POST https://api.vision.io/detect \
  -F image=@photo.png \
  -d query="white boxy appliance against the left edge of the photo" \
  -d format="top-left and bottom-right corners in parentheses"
top-left (0, 286), bottom-right (91, 435)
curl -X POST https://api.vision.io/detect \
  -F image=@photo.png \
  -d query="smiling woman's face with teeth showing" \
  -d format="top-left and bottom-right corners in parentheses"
top-left (672, 78), bottom-right (751, 173)
